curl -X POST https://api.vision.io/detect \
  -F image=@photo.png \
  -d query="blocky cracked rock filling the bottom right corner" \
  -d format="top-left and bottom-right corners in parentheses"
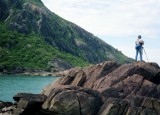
top-left (98, 95), bottom-right (160, 115)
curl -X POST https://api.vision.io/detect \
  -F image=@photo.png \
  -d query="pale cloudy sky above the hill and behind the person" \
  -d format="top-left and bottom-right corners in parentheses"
top-left (42, 0), bottom-right (160, 65)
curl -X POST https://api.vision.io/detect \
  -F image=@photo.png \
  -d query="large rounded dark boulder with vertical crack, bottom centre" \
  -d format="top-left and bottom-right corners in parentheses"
top-left (42, 86), bottom-right (102, 115)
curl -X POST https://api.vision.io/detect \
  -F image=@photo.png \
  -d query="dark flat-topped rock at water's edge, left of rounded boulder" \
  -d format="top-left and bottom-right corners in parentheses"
top-left (13, 93), bottom-right (47, 115)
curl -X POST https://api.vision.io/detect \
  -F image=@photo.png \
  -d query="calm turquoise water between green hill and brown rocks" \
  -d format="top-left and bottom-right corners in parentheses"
top-left (0, 75), bottom-right (59, 102)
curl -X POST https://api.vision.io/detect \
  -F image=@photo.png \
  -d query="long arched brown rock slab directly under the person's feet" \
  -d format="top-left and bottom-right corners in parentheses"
top-left (94, 62), bottom-right (160, 90)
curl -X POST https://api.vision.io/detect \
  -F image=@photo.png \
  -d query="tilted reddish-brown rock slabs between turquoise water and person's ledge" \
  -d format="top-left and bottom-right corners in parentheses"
top-left (43, 61), bottom-right (119, 95)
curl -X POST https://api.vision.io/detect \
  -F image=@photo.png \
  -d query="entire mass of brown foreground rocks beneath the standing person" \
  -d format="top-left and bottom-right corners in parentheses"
top-left (0, 61), bottom-right (160, 115)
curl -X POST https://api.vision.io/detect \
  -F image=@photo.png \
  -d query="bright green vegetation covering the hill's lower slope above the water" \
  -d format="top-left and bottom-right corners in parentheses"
top-left (0, 23), bottom-right (89, 70)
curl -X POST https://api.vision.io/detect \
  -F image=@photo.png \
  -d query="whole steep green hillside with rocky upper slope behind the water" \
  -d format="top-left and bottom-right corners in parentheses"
top-left (0, 0), bottom-right (132, 72)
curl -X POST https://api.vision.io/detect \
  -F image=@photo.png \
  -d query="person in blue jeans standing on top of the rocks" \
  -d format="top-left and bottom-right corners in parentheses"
top-left (135, 35), bottom-right (144, 61)
